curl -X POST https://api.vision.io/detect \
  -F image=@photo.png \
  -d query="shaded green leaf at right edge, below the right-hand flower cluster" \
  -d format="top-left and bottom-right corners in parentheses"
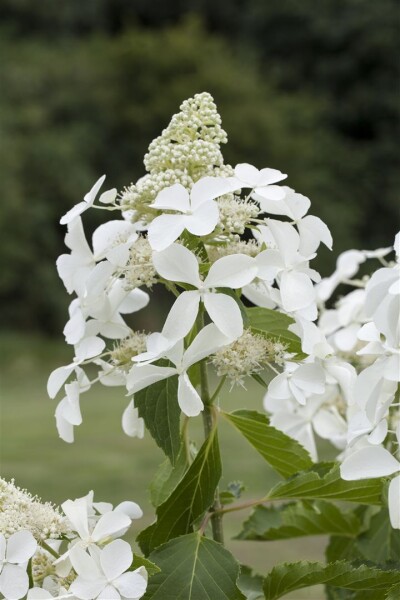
top-left (356, 506), bottom-right (400, 563)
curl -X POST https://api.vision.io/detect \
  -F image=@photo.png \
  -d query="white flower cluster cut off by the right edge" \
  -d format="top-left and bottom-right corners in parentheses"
top-left (264, 233), bottom-right (400, 529)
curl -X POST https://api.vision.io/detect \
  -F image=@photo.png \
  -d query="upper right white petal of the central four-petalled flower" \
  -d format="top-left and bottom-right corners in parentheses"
top-left (204, 254), bottom-right (258, 289)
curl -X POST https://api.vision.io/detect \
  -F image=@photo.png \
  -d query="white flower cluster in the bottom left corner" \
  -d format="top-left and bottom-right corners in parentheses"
top-left (0, 480), bottom-right (147, 600)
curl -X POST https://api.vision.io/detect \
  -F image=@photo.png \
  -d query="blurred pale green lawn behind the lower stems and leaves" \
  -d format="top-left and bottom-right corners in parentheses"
top-left (0, 334), bottom-right (326, 600)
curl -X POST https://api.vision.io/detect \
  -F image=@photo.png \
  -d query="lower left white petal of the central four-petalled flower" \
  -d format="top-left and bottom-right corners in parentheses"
top-left (162, 291), bottom-right (200, 340)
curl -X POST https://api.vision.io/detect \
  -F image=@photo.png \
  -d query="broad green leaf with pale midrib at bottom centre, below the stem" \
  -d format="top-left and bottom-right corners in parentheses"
top-left (143, 532), bottom-right (245, 600)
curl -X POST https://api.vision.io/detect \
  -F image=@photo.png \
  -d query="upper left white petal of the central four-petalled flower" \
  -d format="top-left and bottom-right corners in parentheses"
top-left (153, 244), bottom-right (201, 287)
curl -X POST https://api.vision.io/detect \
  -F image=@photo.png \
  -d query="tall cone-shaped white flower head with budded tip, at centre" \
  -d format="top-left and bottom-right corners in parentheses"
top-left (48, 94), bottom-right (331, 442)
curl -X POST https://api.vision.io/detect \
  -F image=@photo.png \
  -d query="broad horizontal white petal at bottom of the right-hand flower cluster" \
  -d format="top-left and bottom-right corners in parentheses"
top-left (340, 446), bottom-right (400, 481)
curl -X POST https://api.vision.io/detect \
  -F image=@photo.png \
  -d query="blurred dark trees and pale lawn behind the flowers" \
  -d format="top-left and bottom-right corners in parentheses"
top-left (0, 0), bottom-right (400, 598)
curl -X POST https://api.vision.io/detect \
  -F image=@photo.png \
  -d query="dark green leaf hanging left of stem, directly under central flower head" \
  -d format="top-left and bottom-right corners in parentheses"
top-left (135, 376), bottom-right (181, 464)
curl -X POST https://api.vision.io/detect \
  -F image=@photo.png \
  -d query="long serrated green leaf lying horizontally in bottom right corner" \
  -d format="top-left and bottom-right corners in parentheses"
top-left (264, 561), bottom-right (400, 600)
